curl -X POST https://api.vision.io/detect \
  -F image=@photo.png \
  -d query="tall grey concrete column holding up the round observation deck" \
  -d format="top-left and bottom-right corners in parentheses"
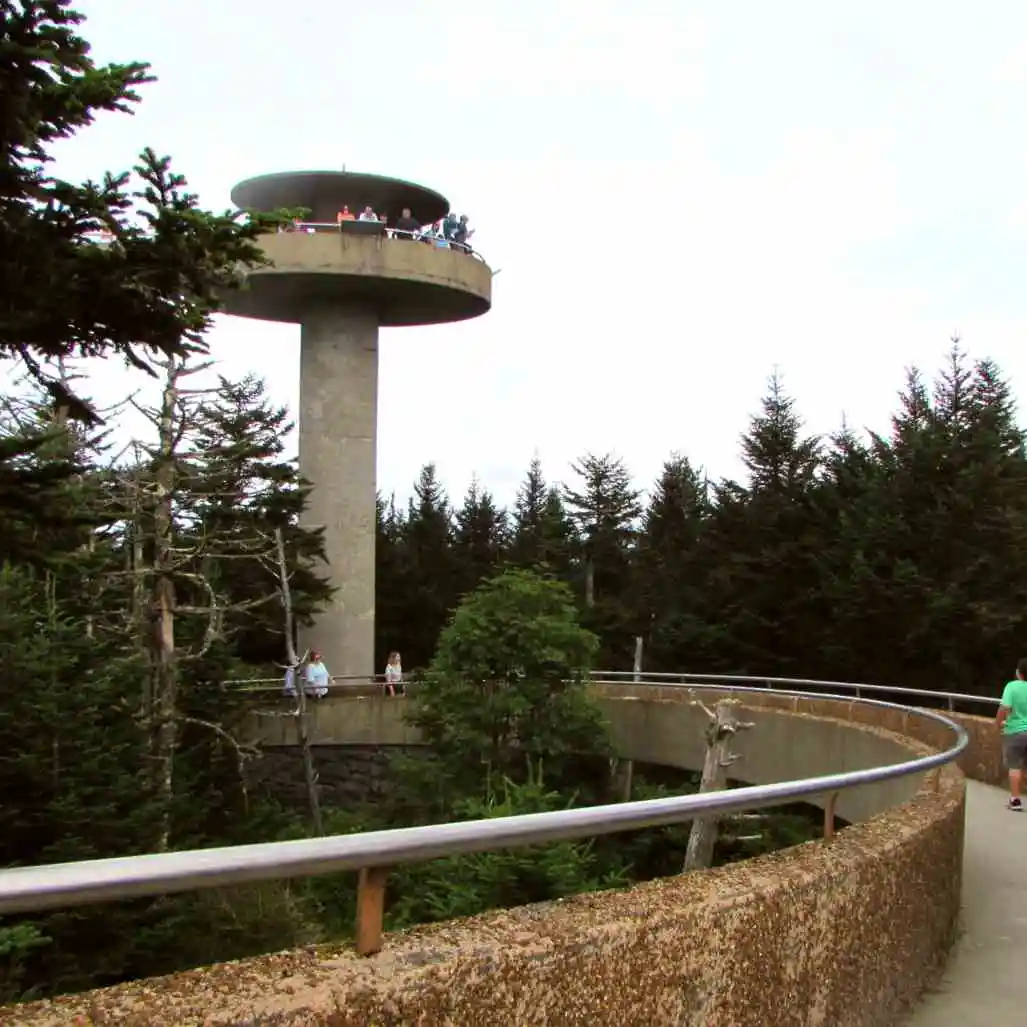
top-left (299, 306), bottom-right (378, 676)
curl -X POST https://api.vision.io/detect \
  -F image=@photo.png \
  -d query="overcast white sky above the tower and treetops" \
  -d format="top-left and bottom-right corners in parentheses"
top-left (58, 0), bottom-right (1027, 502)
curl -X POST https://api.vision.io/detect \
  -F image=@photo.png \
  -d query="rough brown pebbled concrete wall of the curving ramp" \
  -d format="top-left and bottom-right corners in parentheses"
top-left (16, 685), bottom-right (995, 1027)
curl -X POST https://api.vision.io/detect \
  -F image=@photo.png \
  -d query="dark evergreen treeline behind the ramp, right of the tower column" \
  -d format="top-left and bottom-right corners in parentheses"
top-left (377, 341), bottom-right (1027, 694)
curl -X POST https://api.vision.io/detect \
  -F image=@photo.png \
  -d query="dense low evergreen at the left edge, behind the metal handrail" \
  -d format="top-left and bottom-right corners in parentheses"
top-left (0, 550), bottom-right (159, 1001)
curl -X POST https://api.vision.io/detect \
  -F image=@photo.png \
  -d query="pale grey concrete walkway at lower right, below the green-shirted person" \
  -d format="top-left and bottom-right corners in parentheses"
top-left (904, 782), bottom-right (1027, 1027)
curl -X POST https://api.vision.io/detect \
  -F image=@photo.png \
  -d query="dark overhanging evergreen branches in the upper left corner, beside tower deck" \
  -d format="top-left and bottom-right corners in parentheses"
top-left (0, 0), bottom-right (273, 417)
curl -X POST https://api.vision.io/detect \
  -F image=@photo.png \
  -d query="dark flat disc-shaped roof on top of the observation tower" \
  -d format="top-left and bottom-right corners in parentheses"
top-left (232, 172), bottom-right (450, 225)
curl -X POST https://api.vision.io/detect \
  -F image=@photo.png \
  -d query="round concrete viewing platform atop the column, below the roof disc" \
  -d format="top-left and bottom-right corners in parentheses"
top-left (222, 231), bottom-right (492, 328)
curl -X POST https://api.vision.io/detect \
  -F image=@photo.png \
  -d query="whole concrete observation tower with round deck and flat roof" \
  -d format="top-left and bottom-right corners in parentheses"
top-left (225, 172), bottom-right (492, 676)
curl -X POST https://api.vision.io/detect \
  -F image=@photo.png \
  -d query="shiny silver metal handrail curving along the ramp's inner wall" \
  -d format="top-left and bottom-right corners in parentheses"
top-left (0, 675), bottom-right (968, 955)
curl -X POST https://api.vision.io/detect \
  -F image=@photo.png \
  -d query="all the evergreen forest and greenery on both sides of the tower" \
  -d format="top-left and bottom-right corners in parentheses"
top-left (0, 0), bottom-right (1027, 1001)
